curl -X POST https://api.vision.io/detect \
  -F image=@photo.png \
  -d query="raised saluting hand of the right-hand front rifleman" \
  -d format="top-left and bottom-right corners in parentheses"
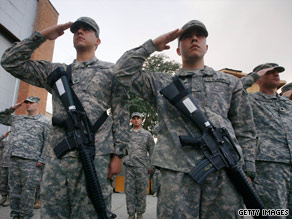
top-left (153, 29), bottom-right (183, 51)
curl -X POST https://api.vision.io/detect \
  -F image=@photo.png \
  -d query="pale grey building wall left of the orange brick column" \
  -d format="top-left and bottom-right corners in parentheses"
top-left (0, 0), bottom-right (37, 134)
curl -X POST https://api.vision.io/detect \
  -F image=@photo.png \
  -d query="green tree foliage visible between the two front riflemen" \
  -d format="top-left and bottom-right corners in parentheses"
top-left (129, 54), bottom-right (180, 133)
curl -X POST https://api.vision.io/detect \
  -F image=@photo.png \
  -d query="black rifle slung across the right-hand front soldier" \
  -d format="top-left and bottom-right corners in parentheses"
top-left (160, 77), bottom-right (270, 218)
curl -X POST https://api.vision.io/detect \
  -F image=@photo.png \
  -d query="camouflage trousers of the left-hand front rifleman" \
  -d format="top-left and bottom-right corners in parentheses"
top-left (41, 155), bottom-right (112, 219)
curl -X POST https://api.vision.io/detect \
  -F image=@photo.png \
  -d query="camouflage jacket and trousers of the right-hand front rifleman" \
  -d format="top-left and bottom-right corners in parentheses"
top-left (114, 40), bottom-right (256, 219)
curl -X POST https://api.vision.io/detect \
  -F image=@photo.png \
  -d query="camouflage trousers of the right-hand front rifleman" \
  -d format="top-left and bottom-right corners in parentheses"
top-left (157, 168), bottom-right (244, 219)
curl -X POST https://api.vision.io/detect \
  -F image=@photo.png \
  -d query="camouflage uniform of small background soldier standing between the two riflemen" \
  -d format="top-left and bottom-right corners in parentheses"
top-left (123, 128), bottom-right (155, 215)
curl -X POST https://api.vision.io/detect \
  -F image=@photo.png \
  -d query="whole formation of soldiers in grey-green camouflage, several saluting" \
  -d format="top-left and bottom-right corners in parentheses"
top-left (0, 17), bottom-right (292, 219)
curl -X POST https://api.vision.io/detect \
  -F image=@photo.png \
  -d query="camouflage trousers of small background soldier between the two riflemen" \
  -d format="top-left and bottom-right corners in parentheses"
top-left (125, 165), bottom-right (149, 215)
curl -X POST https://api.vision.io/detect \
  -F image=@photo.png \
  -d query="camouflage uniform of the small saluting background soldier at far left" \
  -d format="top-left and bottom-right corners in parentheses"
top-left (0, 108), bottom-right (50, 218)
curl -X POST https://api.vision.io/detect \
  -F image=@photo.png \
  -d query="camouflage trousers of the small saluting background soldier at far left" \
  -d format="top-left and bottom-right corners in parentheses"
top-left (9, 156), bottom-right (40, 218)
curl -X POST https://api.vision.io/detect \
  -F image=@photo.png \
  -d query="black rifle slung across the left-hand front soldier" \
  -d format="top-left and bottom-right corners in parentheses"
top-left (48, 67), bottom-right (116, 219)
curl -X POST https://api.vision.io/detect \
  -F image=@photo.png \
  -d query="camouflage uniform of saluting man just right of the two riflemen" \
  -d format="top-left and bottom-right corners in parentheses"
top-left (242, 72), bottom-right (292, 218)
